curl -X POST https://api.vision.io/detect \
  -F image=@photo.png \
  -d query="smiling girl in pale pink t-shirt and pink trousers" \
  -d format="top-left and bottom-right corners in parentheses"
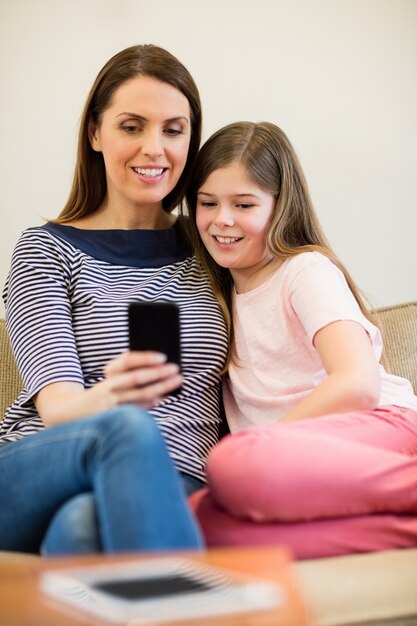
top-left (187, 122), bottom-right (417, 558)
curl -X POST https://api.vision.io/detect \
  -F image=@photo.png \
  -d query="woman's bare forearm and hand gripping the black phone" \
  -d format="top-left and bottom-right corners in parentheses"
top-left (34, 352), bottom-right (182, 426)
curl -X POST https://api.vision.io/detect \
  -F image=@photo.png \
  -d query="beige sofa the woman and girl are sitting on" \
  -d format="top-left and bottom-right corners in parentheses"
top-left (0, 302), bottom-right (417, 626)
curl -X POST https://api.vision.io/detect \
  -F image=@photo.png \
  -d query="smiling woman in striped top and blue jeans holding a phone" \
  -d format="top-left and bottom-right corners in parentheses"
top-left (0, 45), bottom-right (226, 554)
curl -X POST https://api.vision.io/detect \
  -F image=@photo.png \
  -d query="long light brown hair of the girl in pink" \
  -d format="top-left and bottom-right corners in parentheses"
top-left (186, 122), bottom-right (375, 363)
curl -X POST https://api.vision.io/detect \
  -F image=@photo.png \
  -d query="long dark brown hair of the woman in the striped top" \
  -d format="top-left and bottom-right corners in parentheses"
top-left (51, 44), bottom-right (202, 224)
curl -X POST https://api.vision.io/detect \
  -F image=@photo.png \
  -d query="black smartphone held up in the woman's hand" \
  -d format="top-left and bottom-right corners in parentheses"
top-left (128, 300), bottom-right (181, 369)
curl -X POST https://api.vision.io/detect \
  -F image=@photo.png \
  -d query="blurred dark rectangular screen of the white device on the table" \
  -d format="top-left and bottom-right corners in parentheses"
top-left (94, 574), bottom-right (211, 600)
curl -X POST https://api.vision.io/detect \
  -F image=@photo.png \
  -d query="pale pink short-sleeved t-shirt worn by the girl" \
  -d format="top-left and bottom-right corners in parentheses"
top-left (223, 252), bottom-right (417, 432)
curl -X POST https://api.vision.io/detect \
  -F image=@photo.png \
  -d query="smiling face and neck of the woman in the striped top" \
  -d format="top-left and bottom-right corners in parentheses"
top-left (90, 76), bottom-right (191, 219)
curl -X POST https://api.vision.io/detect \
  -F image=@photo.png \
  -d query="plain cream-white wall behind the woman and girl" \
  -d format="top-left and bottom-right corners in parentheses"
top-left (0, 0), bottom-right (417, 316)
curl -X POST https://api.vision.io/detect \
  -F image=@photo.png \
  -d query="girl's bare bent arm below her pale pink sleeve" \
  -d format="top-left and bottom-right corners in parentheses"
top-left (279, 321), bottom-right (380, 422)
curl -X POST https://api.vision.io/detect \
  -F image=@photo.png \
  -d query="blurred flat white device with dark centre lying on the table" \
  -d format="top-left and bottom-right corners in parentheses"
top-left (41, 557), bottom-right (286, 626)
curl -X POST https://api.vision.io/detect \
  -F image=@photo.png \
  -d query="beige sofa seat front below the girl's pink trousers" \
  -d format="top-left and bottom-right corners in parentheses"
top-left (294, 549), bottom-right (417, 626)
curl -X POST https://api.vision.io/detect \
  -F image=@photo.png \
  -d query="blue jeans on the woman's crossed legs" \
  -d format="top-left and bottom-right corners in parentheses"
top-left (0, 405), bottom-right (202, 554)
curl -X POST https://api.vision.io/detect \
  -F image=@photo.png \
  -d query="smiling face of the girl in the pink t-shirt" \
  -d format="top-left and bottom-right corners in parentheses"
top-left (197, 163), bottom-right (275, 285)
